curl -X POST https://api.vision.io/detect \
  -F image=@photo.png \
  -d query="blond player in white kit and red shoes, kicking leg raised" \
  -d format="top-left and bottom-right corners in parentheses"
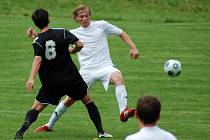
top-left (28, 5), bottom-right (139, 137)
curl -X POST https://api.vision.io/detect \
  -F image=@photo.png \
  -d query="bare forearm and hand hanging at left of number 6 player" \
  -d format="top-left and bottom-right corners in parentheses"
top-left (26, 56), bottom-right (42, 92)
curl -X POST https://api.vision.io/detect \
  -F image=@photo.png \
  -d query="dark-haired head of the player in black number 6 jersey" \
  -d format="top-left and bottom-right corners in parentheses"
top-left (31, 8), bottom-right (49, 29)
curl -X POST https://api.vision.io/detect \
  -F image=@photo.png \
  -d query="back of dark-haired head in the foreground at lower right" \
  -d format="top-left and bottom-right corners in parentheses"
top-left (136, 96), bottom-right (161, 124)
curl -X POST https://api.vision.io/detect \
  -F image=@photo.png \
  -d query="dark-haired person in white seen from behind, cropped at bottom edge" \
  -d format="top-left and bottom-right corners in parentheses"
top-left (125, 96), bottom-right (177, 140)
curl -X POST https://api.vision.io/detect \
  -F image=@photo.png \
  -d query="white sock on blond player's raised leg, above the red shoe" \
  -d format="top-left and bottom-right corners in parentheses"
top-left (115, 85), bottom-right (128, 113)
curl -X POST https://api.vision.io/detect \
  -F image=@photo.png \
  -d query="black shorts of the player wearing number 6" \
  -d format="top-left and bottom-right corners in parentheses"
top-left (36, 83), bottom-right (87, 105)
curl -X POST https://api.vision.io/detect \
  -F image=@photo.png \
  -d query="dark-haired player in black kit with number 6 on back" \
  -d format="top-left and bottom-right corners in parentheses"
top-left (14, 9), bottom-right (104, 139)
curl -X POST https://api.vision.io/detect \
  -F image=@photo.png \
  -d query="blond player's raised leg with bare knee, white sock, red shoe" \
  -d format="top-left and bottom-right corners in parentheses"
top-left (110, 71), bottom-right (135, 122)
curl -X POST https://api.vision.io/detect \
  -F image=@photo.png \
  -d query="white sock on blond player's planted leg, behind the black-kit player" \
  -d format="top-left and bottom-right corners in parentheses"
top-left (47, 102), bottom-right (68, 129)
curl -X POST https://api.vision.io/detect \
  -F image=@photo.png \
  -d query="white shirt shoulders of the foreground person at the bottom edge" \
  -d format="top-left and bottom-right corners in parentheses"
top-left (125, 126), bottom-right (177, 140)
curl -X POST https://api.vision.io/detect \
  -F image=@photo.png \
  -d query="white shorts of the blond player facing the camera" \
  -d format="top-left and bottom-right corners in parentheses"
top-left (79, 65), bottom-right (120, 91)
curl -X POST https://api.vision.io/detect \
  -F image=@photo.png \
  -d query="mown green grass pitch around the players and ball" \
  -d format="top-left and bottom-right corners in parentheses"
top-left (0, 0), bottom-right (210, 140)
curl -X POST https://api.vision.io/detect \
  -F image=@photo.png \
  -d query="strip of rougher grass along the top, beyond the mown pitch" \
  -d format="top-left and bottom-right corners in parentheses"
top-left (0, 0), bottom-right (210, 22)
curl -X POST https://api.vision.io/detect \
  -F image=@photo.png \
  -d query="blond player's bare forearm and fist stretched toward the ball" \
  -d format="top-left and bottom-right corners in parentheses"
top-left (119, 32), bottom-right (139, 59)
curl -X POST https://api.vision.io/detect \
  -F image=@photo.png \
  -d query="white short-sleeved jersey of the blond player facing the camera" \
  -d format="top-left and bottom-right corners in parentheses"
top-left (70, 20), bottom-right (122, 70)
